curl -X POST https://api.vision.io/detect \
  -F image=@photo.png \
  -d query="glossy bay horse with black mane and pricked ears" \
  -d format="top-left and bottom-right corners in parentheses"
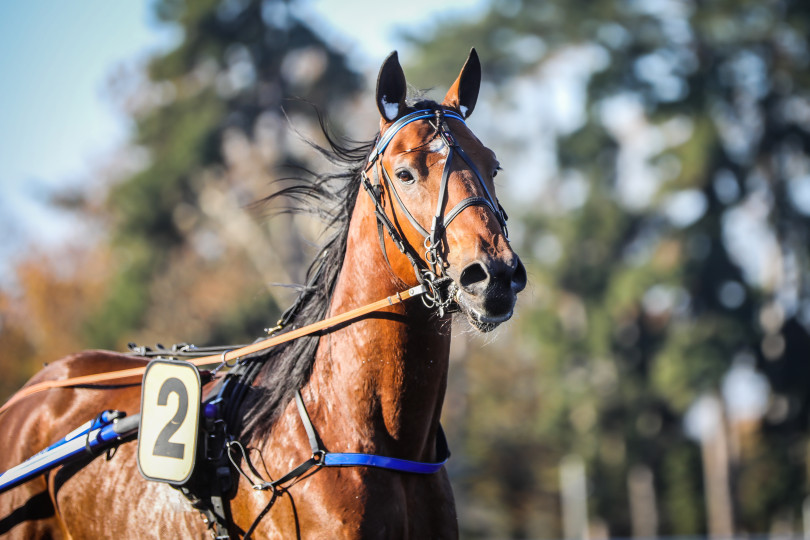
top-left (0, 49), bottom-right (526, 539)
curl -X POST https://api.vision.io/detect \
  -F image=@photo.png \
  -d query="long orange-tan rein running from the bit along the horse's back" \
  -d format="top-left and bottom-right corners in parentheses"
top-left (0, 285), bottom-right (426, 414)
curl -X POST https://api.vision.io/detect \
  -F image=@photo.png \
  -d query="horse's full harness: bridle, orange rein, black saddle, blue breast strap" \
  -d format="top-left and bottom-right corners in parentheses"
top-left (0, 109), bottom-right (507, 539)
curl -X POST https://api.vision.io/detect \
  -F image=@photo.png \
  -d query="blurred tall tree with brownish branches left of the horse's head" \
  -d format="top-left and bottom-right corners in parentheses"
top-left (85, 0), bottom-right (361, 348)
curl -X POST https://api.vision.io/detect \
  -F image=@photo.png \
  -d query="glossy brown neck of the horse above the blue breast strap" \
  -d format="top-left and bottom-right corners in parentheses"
top-left (305, 193), bottom-right (450, 460)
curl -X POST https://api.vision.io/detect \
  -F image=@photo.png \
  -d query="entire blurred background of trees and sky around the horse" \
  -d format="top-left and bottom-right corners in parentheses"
top-left (0, 0), bottom-right (810, 539)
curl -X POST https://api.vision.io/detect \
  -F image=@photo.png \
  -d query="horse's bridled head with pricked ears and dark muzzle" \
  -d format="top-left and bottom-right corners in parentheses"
top-left (364, 49), bottom-right (526, 331)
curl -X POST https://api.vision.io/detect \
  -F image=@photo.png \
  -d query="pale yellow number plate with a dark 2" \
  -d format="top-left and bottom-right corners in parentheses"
top-left (138, 360), bottom-right (202, 484)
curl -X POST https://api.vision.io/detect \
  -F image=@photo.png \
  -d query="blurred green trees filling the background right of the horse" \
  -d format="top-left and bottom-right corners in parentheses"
top-left (409, 0), bottom-right (810, 537)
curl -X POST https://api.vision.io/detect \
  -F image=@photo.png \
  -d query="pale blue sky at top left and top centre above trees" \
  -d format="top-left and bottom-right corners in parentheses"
top-left (0, 0), bottom-right (484, 270)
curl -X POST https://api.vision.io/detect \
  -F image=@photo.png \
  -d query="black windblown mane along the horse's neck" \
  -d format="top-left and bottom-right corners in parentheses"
top-left (241, 100), bottom-right (439, 438)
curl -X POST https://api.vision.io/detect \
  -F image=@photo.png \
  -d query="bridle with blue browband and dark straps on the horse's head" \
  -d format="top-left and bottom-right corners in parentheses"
top-left (360, 108), bottom-right (509, 317)
